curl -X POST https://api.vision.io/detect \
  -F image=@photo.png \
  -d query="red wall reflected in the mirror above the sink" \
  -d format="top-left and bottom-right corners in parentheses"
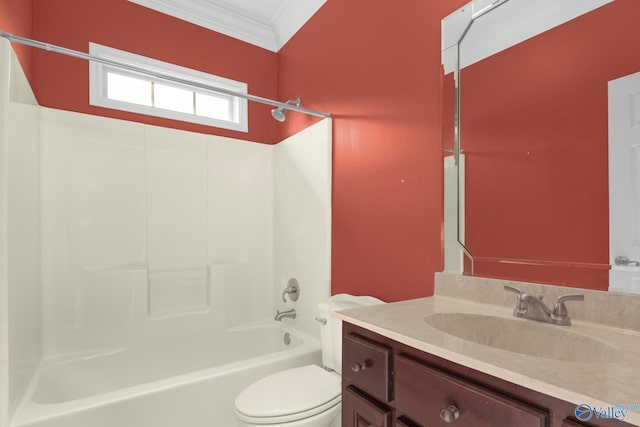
top-left (461, 0), bottom-right (640, 290)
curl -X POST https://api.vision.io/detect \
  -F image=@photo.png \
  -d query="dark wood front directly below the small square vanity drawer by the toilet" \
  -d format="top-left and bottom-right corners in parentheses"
top-left (342, 386), bottom-right (393, 427)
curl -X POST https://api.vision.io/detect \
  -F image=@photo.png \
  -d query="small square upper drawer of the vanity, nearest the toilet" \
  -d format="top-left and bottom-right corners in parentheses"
top-left (342, 334), bottom-right (393, 402)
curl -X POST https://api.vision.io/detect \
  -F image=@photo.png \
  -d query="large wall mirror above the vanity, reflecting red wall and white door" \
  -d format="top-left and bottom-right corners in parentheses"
top-left (443, 0), bottom-right (640, 292)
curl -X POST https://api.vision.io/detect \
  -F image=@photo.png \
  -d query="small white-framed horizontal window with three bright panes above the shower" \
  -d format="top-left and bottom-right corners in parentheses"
top-left (89, 43), bottom-right (248, 132)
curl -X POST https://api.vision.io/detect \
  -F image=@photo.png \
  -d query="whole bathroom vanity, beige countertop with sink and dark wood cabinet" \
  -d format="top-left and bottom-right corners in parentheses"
top-left (336, 274), bottom-right (640, 427)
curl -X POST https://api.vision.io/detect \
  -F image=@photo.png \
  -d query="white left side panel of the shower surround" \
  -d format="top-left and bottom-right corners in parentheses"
top-left (0, 40), bottom-right (42, 427)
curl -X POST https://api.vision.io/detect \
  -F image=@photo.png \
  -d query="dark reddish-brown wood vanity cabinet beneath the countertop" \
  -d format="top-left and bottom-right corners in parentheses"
top-left (342, 322), bottom-right (639, 427)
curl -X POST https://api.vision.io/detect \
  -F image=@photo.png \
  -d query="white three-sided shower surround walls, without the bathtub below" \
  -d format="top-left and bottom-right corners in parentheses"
top-left (0, 40), bottom-right (331, 427)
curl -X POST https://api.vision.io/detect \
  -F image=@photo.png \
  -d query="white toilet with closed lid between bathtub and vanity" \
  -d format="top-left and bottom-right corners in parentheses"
top-left (235, 294), bottom-right (384, 427)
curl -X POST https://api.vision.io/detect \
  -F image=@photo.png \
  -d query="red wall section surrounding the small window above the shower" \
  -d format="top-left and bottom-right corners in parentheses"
top-left (30, 0), bottom-right (277, 143)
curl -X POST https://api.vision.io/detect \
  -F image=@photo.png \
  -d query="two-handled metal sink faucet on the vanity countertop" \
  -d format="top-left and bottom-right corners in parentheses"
top-left (504, 285), bottom-right (584, 326)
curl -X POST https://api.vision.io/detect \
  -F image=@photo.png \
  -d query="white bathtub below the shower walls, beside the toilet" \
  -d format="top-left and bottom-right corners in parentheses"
top-left (11, 321), bottom-right (321, 427)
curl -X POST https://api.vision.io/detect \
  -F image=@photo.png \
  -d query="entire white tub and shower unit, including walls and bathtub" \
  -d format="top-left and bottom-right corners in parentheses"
top-left (0, 38), bottom-right (331, 427)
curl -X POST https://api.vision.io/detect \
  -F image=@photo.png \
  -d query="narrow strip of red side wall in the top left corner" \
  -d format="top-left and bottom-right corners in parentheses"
top-left (0, 0), bottom-right (33, 82)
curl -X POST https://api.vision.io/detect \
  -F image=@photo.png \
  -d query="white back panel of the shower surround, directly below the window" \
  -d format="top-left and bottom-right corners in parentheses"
top-left (43, 109), bottom-right (275, 355)
